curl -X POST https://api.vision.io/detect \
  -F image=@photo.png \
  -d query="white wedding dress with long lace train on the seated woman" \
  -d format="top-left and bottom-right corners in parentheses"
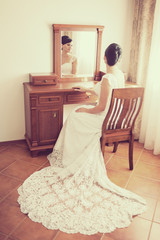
top-left (18, 74), bottom-right (146, 235)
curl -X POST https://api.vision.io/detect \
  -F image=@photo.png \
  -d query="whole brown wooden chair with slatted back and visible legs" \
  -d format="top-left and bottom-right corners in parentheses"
top-left (101, 87), bottom-right (144, 170)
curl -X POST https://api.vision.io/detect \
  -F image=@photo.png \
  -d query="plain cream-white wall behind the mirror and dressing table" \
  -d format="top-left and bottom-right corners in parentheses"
top-left (0, 0), bottom-right (133, 141)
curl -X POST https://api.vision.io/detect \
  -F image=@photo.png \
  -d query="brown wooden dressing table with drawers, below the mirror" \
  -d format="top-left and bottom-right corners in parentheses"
top-left (24, 81), bottom-right (97, 157)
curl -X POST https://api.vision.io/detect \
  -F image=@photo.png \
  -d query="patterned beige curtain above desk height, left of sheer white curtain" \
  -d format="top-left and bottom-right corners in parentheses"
top-left (128, 0), bottom-right (156, 86)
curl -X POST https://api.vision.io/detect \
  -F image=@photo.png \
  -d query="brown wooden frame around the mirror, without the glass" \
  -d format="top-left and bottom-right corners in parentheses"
top-left (52, 24), bottom-right (104, 81)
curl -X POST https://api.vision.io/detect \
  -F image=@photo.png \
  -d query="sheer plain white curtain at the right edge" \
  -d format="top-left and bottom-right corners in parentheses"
top-left (140, 0), bottom-right (160, 155)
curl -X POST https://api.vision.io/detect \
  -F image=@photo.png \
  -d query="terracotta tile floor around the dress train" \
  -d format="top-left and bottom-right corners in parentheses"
top-left (0, 141), bottom-right (160, 240)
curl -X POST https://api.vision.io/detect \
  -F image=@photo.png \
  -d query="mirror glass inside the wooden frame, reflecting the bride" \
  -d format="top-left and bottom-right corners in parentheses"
top-left (61, 31), bottom-right (97, 77)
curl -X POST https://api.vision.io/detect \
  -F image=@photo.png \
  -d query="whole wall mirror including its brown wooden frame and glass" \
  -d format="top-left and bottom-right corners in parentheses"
top-left (53, 24), bottom-right (104, 81)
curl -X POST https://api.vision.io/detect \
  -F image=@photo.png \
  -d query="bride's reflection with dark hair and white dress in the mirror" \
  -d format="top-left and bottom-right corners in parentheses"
top-left (61, 35), bottom-right (77, 75)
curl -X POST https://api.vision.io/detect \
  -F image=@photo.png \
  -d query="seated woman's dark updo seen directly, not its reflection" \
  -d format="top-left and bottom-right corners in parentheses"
top-left (105, 43), bottom-right (122, 66)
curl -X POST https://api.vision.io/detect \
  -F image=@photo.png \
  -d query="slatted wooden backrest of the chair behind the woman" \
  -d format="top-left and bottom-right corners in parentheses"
top-left (102, 87), bottom-right (144, 132)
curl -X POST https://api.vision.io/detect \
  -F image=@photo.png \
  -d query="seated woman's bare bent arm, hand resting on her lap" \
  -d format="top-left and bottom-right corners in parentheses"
top-left (76, 79), bottom-right (110, 114)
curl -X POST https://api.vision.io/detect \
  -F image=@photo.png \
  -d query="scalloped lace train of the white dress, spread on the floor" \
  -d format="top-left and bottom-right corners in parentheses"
top-left (18, 167), bottom-right (145, 235)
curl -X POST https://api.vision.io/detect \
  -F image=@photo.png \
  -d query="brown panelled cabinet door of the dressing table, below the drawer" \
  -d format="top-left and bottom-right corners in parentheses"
top-left (37, 105), bottom-right (63, 145)
